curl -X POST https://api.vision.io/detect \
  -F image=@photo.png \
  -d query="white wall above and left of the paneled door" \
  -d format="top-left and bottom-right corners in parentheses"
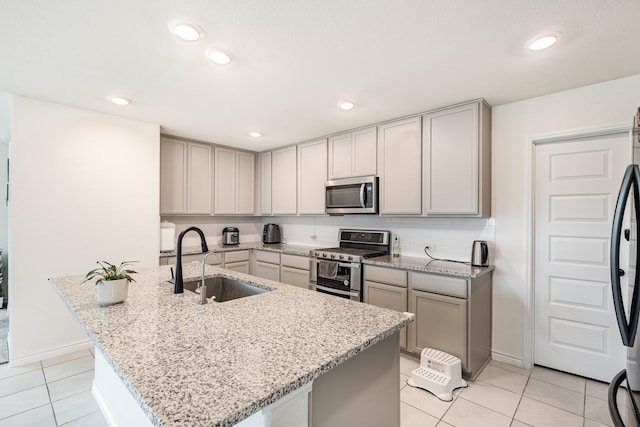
top-left (492, 75), bottom-right (640, 363)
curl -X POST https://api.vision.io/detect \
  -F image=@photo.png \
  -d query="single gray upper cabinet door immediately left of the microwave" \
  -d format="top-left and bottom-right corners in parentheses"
top-left (298, 139), bottom-right (327, 215)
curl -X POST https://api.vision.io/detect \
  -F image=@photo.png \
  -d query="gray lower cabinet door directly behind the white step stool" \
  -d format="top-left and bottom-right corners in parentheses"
top-left (408, 289), bottom-right (467, 369)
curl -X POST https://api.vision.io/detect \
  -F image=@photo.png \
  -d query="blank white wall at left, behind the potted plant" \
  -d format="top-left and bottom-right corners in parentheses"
top-left (9, 96), bottom-right (160, 364)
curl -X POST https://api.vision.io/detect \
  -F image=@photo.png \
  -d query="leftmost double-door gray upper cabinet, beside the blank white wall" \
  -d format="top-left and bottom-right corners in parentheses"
top-left (160, 137), bottom-right (212, 215)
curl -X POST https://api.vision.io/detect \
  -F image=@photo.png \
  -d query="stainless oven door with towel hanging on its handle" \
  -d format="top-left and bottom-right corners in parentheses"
top-left (316, 259), bottom-right (362, 301)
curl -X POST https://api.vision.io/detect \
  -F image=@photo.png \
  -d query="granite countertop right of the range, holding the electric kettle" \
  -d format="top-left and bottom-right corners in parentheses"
top-left (362, 255), bottom-right (495, 279)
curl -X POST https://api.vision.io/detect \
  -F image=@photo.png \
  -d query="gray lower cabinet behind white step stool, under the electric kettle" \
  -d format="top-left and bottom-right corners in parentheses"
top-left (407, 272), bottom-right (492, 380)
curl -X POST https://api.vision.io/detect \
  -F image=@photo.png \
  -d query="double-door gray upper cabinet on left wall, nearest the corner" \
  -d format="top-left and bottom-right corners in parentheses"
top-left (214, 147), bottom-right (255, 215)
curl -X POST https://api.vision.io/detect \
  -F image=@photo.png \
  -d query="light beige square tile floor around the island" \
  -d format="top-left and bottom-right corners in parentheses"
top-left (0, 350), bottom-right (626, 427)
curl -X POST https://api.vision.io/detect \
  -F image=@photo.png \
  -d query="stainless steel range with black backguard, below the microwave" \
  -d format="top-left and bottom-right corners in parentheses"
top-left (313, 229), bottom-right (391, 301)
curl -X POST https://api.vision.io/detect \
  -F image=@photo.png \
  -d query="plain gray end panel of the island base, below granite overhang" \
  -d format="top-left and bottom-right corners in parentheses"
top-left (311, 332), bottom-right (400, 427)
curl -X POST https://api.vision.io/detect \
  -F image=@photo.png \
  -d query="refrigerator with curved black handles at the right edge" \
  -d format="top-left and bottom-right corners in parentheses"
top-left (607, 153), bottom-right (640, 427)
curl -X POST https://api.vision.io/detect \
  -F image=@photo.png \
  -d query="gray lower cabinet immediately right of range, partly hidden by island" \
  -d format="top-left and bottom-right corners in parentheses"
top-left (363, 265), bottom-right (407, 349)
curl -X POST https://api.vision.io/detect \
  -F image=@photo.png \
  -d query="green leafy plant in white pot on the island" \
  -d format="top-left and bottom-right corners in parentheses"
top-left (82, 261), bottom-right (137, 305)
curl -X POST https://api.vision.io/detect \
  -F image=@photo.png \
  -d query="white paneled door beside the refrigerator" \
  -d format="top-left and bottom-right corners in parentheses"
top-left (534, 133), bottom-right (631, 382)
